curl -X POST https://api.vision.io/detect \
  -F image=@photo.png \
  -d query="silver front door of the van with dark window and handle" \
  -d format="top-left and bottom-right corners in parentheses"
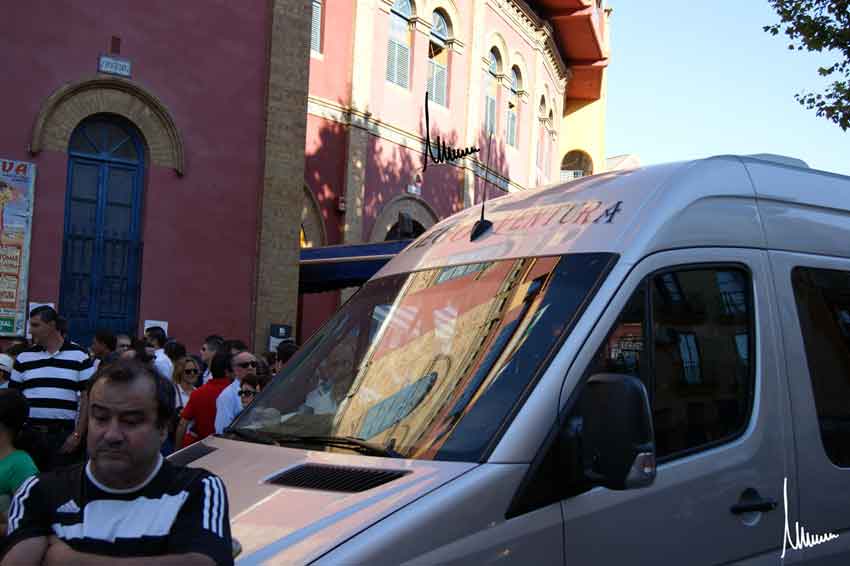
top-left (561, 248), bottom-right (793, 566)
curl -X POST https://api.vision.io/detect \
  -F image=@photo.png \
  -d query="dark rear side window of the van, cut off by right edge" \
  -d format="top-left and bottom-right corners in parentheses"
top-left (791, 267), bottom-right (850, 468)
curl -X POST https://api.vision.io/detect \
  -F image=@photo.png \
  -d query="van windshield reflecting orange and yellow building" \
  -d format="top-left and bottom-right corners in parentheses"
top-left (232, 253), bottom-right (615, 461)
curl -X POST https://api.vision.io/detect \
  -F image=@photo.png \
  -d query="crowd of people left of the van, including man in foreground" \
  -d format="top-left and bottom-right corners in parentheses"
top-left (0, 306), bottom-right (296, 565)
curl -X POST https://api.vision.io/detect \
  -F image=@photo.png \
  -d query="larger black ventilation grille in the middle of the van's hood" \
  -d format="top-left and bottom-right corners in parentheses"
top-left (268, 464), bottom-right (410, 493)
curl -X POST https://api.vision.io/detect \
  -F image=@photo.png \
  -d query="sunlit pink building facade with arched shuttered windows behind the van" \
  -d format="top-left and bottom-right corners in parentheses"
top-left (300, 0), bottom-right (607, 337)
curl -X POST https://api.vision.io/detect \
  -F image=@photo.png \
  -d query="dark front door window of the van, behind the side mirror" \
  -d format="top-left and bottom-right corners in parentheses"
top-left (589, 267), bottom-right (754, 460)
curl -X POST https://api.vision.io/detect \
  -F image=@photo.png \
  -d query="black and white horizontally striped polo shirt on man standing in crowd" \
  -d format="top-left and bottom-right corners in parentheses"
top-left (9, 340), bottom-right (95, 422)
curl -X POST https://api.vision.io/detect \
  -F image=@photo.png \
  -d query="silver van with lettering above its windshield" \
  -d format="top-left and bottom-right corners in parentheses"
top-left (173, 156), bottom-right (850, 566)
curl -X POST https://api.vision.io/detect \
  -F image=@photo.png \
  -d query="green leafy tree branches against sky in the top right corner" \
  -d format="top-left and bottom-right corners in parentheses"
top-left (764, 0), bottom-right (850, 132)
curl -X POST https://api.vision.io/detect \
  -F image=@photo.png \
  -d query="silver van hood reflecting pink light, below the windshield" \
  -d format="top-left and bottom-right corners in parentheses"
top-left (176, 437), bottom-right (478, 564)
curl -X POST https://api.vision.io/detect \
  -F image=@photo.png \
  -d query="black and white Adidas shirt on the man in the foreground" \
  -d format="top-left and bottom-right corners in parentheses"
top-left (4, 456), bottom-right (233, 564)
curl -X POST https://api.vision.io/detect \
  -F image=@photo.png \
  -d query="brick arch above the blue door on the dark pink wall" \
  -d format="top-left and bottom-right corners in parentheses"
top-left (30, 75), bottom-right (185, 175)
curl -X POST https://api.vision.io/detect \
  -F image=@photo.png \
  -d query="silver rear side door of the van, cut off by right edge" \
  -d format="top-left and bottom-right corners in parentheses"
top-left (770, 252), bottom-right (850, 565)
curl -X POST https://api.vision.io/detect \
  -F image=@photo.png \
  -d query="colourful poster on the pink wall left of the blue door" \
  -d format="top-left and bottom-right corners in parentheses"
top-left (0, 158), bottom-right (35, 336)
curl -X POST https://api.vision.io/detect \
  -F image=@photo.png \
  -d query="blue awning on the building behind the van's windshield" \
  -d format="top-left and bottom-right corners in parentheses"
top-left (298, 240), bottom-right (413, 293)
